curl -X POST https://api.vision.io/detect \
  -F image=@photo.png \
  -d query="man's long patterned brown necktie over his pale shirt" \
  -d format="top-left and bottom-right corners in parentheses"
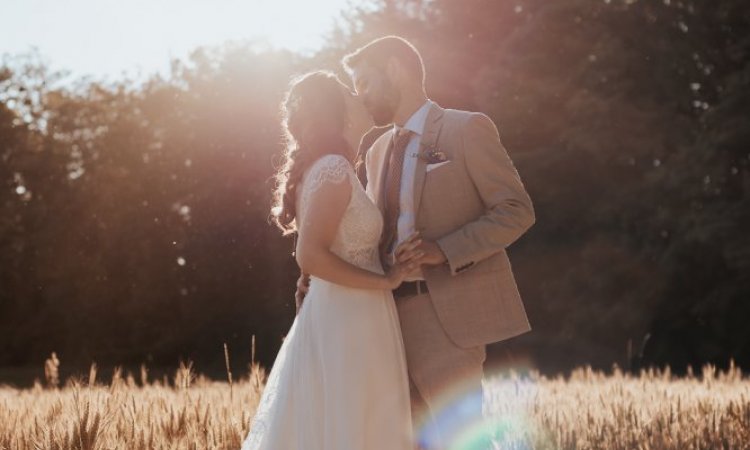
top-left (379, 128), bottom-right (412, 267)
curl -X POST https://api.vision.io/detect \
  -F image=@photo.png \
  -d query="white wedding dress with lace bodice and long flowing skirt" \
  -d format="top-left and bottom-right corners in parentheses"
top-left (242, 154), bottom-right (413, 450)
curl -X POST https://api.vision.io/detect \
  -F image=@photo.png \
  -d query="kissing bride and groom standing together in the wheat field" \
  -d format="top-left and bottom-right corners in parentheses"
top-left (242, 36), bottom-right (535, 450)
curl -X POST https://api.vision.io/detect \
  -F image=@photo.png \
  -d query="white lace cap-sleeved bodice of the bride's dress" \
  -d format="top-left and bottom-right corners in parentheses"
top-left (297, 154), bottom-right (383, 273)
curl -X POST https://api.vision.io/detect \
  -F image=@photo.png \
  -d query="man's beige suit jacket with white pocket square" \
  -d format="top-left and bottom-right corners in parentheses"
top-left (366, 104), bottom-right (535, 348)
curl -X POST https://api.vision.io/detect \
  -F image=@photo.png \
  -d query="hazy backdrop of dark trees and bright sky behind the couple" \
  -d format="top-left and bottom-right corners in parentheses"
top-left (0, 0), bottom-right (750, 384)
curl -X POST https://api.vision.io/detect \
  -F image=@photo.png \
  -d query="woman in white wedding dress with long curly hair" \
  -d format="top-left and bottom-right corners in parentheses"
top-left (242, 72), bottom-right (420, 450)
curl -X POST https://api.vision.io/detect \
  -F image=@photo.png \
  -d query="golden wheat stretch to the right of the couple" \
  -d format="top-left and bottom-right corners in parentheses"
top-left (485, 365), bottom-right (750, 450)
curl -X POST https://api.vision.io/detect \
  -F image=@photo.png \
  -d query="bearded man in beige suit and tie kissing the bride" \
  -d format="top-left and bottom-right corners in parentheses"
top-left (300, 36), bottom-right (535, 448)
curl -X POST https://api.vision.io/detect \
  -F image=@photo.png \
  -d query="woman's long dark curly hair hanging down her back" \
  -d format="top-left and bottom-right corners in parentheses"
top-left (271, 71), bottom-right (353, 235)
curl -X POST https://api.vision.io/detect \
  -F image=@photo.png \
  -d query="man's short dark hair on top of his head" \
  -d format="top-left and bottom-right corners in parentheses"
top-left (341, 36), bottom-right (424, 85)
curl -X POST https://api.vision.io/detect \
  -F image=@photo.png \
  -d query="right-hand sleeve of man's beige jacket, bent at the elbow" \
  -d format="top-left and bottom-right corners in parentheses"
top-left (437, 113), bottom-right (535, 275)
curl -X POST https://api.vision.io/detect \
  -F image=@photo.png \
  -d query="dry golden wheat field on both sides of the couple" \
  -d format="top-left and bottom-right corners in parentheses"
top-left (0, 358), bottom-right (750, 450)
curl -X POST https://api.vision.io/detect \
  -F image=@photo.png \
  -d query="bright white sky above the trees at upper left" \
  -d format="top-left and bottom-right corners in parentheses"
top-left (0, 0), bottom-right (356, 79)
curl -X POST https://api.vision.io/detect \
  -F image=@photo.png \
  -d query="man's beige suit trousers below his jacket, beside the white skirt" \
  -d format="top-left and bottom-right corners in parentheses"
top-left (396, 293), bottom-right (487, 450)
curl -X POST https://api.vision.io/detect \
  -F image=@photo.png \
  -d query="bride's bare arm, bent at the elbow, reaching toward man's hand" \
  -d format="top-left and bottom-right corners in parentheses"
top-left (295, 172), bottom-right (413, 289)
